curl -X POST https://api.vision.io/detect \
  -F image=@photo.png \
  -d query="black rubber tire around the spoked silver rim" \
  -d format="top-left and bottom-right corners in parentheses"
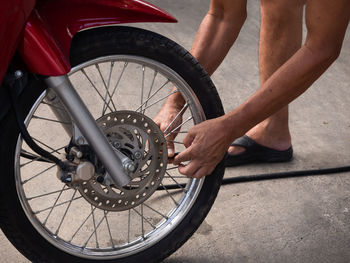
top-left (0, 27), bottom-right (224, 262)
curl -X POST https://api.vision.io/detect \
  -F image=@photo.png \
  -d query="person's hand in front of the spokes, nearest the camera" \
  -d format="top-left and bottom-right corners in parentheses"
top-left (174, 117), bottom-right (232, 178)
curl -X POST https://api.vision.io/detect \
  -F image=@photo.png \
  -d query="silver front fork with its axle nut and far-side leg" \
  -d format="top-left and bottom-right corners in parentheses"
top-left (45, 75), bottom-right (134, 187)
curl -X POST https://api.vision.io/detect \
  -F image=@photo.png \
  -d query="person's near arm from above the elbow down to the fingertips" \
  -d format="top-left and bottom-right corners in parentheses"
top-left (174, 0), bottom-right (350, 178)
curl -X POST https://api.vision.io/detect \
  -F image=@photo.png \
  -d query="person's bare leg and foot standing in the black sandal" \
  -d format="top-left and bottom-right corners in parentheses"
top-left (229, 0), bottom-right (305, 155)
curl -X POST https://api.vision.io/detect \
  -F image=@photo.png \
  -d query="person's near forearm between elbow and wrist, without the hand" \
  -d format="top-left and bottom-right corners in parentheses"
top-left (223, 45), bottom-right (336, 139)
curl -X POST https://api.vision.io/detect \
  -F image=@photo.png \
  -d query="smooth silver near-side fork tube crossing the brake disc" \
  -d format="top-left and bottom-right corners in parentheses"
top-left (46, 75), bottom-right (131, 187)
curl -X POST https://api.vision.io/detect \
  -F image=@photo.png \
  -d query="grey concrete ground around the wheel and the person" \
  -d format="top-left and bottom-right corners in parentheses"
top-left (0, 0), bottom-right (350, 263)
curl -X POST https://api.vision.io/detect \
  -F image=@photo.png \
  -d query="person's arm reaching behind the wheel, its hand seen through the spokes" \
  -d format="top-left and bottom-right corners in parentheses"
top-left (154, 0), bottom-right (247, 157)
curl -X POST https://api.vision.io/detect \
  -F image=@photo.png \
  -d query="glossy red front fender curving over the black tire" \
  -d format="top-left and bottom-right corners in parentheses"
top-left (19, 0), bottom-right (177, 76)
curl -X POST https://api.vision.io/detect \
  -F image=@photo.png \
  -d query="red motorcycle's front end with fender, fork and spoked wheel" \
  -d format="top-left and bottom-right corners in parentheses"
top-left (0, 0), bottom-right (223, 262)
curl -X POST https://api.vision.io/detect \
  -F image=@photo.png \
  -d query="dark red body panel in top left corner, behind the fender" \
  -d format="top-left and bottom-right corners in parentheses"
top-left (0, 0), bottom-right (35, 83)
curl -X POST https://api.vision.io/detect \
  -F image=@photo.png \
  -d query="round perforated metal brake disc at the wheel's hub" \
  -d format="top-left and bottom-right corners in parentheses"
top-left (78, 111), bottom-right (168, 211)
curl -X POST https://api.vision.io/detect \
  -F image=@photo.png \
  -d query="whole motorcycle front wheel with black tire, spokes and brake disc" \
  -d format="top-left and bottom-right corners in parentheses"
top-left (0, 27), bottom-right (224, 262)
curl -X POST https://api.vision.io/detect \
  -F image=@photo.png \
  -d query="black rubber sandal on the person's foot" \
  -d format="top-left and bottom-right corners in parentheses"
top-left (225, 135), bottom-right (293, 167)
